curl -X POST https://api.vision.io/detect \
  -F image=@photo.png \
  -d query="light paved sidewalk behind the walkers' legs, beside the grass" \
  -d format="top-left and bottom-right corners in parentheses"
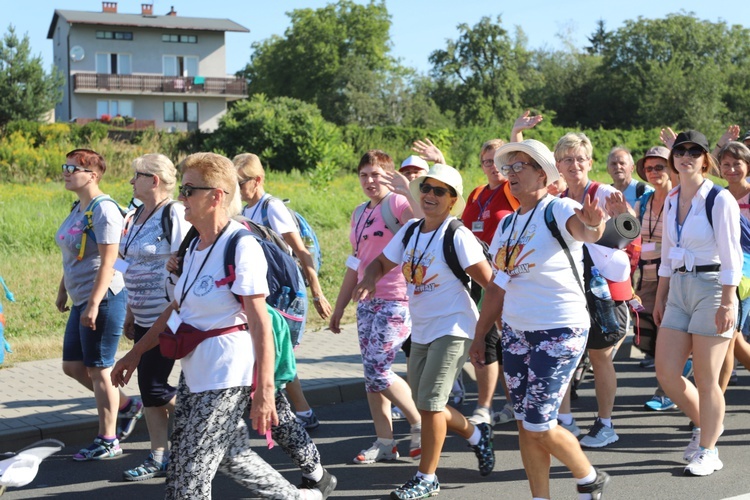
top-left (0, 324), bottom-right (378, 453)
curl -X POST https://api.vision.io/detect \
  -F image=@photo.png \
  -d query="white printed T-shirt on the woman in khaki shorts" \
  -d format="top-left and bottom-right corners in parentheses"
top-left (383, 217), bottom-right (484, 344)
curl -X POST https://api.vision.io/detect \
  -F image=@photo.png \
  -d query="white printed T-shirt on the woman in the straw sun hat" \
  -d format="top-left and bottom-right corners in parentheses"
top-left (490, 195), bottom-right (590, 331)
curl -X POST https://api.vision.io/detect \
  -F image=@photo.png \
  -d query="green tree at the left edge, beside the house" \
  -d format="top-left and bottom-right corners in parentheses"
top-left (0, 25), bottom-right (64, 126)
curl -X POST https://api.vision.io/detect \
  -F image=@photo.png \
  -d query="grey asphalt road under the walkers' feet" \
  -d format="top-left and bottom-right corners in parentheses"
top-left (2, 361), bottom-right (750, 500)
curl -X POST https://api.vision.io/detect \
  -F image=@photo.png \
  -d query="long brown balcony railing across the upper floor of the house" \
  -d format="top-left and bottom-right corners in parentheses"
top-left (73, 73), bottom-right (247, 97)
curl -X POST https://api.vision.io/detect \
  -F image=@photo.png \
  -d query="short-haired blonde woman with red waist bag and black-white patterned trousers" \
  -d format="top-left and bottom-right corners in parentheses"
top-left (112, 153), bottom-right (322, 499)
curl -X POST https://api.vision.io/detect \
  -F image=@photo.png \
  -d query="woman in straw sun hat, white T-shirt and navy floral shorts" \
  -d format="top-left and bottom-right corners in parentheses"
top-left (470, 140), bottom-right (609, 498)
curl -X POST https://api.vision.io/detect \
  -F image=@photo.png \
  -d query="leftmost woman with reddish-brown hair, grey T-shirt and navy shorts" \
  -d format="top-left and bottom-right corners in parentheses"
top-left (55, 149), bottom-right (129, 461)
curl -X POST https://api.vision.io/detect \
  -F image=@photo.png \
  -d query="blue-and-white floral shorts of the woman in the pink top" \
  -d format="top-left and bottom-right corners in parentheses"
top-left (357, 299), bottom-right (411, 392)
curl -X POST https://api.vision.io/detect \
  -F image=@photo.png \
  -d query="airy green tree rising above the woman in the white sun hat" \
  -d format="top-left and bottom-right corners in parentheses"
top-left (430, 16), bottom-right (529, 125)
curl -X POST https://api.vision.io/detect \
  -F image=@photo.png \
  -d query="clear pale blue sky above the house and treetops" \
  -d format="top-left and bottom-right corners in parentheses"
top-left (0, 0), bottom-right (750, 73)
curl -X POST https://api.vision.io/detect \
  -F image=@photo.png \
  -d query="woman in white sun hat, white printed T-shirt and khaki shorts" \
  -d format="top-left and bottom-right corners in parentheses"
top-left (352, 163), bottom-right (495, 499)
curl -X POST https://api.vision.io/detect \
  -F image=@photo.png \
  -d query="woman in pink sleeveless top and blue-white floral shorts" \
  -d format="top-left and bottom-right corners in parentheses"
top-left (329, 149), bottom-right (421, 464)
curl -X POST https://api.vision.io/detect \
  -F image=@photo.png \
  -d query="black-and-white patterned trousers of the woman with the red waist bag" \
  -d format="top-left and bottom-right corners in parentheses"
top-left (165, 375), bottom-right (299, 500)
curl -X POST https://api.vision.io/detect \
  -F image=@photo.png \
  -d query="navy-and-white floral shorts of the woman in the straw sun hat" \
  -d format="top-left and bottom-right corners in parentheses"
top-left (502, 323), bottom-right (588, 432)
